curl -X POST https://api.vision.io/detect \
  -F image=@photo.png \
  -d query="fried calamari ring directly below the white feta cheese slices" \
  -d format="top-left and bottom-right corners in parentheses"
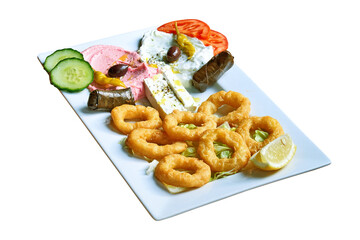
top-left (163, 110), bottom-right (216, 141)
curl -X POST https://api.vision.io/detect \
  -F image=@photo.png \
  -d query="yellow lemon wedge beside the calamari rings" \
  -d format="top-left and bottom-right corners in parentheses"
top-left (250, 134), bottom-right (296, 171)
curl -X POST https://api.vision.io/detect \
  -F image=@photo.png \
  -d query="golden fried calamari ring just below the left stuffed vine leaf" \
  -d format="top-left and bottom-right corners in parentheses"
top-left (111, 104), bottom-right (162, 134)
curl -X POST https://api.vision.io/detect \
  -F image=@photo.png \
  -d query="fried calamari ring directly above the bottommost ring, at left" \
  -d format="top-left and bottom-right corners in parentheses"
top-left (126, 128), bottom-right (187, 160)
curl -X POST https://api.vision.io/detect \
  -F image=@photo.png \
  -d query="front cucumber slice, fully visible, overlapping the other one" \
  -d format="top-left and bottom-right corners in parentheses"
top-left (50, 58), bottom-right (94, 92)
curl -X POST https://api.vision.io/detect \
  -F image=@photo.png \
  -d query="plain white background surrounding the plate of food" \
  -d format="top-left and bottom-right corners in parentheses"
top-left (0, 0), bottom-right (360, 240)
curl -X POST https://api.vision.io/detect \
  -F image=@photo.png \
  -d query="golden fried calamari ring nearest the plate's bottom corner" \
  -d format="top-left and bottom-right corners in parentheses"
top-left (155, 154), bottom-right (211, 188)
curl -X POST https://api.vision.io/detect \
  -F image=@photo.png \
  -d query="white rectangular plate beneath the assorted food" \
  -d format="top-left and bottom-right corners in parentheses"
top-left (38, 29), bottom-right (330, 220)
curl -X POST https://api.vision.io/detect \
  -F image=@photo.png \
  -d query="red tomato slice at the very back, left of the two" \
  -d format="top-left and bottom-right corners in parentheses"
top-left (157, 19), bottom-right (210, 40)
